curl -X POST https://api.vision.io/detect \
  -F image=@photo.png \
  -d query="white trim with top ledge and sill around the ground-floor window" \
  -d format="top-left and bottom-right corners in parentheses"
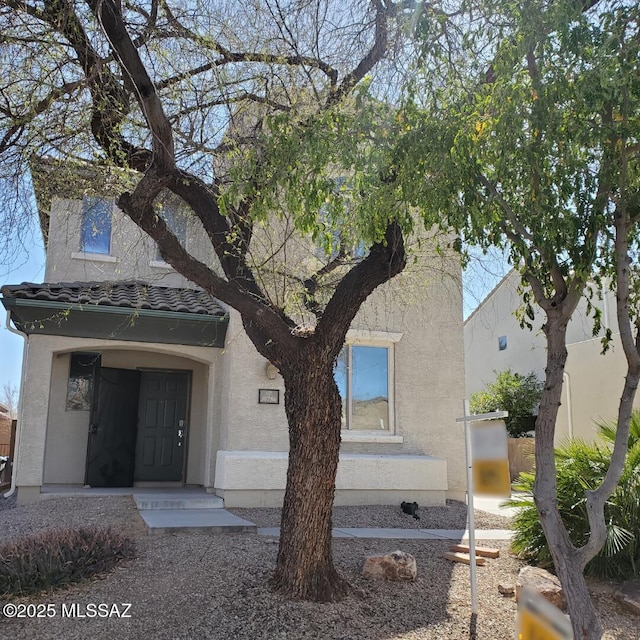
top-left (340, 329), bottom-right (404, 444)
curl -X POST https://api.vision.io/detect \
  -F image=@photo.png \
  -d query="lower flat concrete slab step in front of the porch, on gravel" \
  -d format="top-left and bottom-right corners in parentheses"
top-left (139, 509), bottom-right (257, 535)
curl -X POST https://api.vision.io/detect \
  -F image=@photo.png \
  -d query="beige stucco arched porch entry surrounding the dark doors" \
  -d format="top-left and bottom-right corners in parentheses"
top-left (16, 335), bottom-right (223, 500)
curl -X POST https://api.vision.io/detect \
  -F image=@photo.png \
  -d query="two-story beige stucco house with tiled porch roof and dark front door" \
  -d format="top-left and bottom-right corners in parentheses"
top-left (1, 168), bottom-right (465, 507)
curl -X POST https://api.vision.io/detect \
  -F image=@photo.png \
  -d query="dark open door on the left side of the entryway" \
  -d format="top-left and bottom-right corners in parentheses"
top-left (85, 367), bottom-right (140, 487)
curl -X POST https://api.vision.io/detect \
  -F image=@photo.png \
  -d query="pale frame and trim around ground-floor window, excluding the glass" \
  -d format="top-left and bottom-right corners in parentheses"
top-left (340, 329), bottom-right (402, 441)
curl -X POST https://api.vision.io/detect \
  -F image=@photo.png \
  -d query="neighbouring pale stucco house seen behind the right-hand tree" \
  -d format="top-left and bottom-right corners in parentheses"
top-left (464, 270), bottom-right (640, 444)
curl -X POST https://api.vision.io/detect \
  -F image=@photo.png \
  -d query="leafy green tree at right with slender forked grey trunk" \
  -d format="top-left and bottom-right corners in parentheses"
top-left (393, 0), bottom-right (640, 640)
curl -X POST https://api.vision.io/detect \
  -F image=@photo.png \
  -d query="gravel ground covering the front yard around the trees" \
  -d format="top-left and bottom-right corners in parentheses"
top-left (0, 497), bottom-right (639, 640)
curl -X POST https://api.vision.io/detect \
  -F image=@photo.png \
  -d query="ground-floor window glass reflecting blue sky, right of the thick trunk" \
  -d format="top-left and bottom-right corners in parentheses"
top-left (334, 344), bottom-right (393, 431)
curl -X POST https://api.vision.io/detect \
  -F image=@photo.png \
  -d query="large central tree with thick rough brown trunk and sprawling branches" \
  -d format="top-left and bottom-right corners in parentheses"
top-left (0, 0), bottom-right (440, 600)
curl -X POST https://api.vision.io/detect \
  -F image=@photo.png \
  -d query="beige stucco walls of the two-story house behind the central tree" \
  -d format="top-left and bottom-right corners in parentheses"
top-left (19, 198), bottom-right (465, 501)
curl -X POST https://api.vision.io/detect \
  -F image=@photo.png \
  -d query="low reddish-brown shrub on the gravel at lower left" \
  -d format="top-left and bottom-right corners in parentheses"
top-left (0, 527), bottom-right (135, 596)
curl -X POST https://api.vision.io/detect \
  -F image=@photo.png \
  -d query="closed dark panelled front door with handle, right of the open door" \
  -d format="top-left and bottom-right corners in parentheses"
top-left (135, 371), bottom-right (189, 482)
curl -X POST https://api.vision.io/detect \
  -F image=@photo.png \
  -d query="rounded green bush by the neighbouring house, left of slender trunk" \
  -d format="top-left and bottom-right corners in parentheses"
top-left (469, 369), bottom-right (542, 438)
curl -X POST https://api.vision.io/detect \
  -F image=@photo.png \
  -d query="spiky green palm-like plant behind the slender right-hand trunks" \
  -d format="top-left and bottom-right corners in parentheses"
top-left (508, 411), bottom-right (640, 580)
